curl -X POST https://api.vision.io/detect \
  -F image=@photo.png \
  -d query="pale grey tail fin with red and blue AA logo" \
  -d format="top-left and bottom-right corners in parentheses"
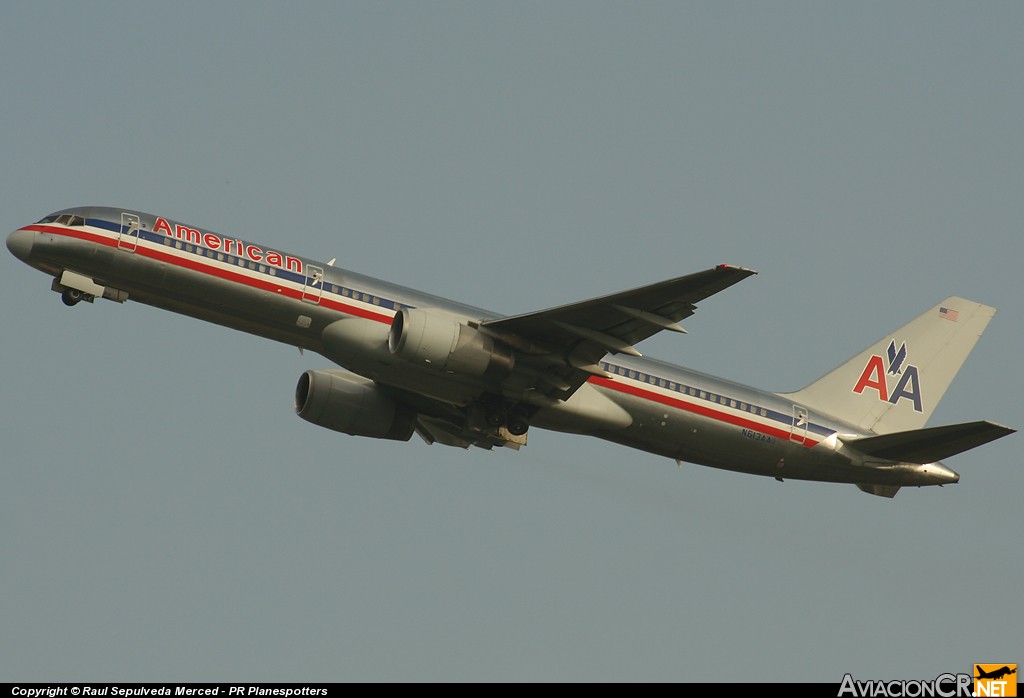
top-left (787, 298), bottom-right (995, 434)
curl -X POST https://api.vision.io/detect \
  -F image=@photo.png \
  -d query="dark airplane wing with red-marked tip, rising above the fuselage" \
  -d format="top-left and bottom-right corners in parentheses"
top-left (479, 264), bottom-right (757, 404)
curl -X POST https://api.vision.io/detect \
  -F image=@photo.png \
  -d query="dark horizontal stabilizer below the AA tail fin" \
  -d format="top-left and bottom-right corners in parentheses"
top-left (843, 422), bottom-right (1017, 464)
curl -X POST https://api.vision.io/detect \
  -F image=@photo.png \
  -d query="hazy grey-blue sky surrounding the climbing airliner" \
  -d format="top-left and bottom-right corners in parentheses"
top-left (0, 1), bottom-right (1024, 683)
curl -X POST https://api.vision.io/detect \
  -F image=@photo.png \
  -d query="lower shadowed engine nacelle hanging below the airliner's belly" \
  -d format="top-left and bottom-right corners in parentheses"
top-left (295, 370), bottom-right (416, 441)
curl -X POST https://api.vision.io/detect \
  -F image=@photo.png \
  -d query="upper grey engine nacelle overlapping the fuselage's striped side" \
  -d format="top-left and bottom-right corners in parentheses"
top-left (387, 308), bottom-right (515, 378)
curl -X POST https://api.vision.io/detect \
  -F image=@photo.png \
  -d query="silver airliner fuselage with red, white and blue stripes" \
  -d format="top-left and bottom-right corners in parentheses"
top-left (8, 207), bottom-right (958, 485)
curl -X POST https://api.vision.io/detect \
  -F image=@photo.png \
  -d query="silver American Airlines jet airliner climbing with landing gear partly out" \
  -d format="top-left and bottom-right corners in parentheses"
top-left (7, 207), bottom-right (1014, 497)
